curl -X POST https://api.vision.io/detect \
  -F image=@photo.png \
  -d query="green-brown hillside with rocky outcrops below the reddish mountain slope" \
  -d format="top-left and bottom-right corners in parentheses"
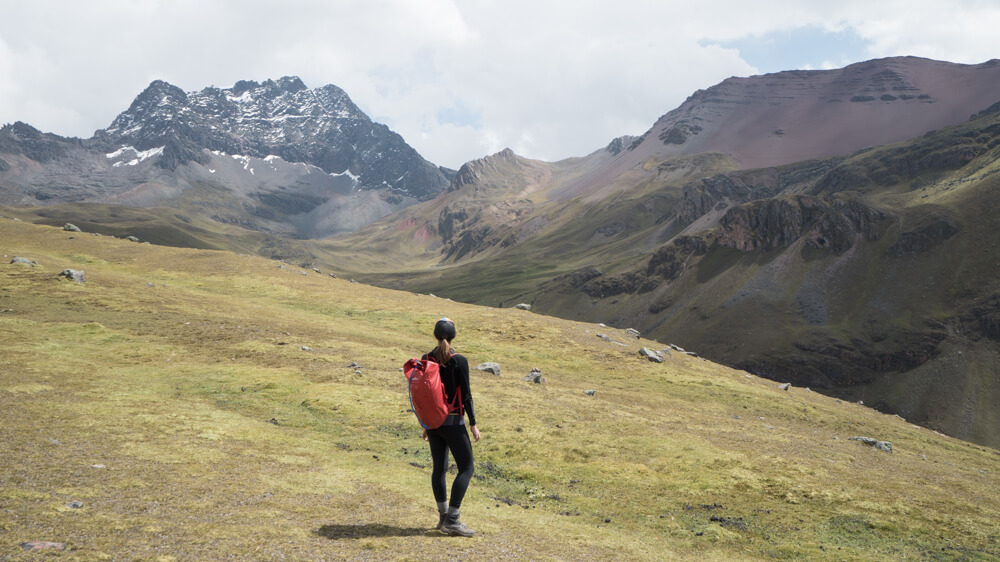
top-left (314, 108), bottom-right (1000, 447)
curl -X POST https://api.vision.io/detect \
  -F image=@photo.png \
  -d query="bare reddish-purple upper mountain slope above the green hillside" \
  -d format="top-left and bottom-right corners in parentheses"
top-left (558, 57), bottom-right (1000, 202)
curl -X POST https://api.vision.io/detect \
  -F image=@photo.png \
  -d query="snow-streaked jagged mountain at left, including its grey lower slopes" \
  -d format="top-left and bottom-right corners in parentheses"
top-left (0, 77), bottom-right (454, 238)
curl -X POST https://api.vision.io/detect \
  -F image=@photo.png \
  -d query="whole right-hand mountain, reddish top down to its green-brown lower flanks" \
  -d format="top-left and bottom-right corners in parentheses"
top-left (318, 57), bottom-right (1000, 446)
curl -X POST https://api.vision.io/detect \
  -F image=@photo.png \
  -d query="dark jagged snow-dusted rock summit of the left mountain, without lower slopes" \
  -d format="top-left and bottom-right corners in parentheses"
top-left (95, 77), bottom-right (449, 199)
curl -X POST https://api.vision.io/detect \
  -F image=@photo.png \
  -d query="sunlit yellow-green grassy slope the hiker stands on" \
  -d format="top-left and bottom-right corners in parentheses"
top-left (0, 219), bottom-right (1000, 560)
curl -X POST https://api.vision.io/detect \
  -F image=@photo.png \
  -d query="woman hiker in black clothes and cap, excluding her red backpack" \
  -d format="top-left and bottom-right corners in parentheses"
top-left (422, 318), bottom-right (480, 537)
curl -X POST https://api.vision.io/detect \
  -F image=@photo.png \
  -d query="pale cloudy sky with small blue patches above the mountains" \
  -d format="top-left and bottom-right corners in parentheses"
top-left (0, 0), bottom-right (1000, 168)
